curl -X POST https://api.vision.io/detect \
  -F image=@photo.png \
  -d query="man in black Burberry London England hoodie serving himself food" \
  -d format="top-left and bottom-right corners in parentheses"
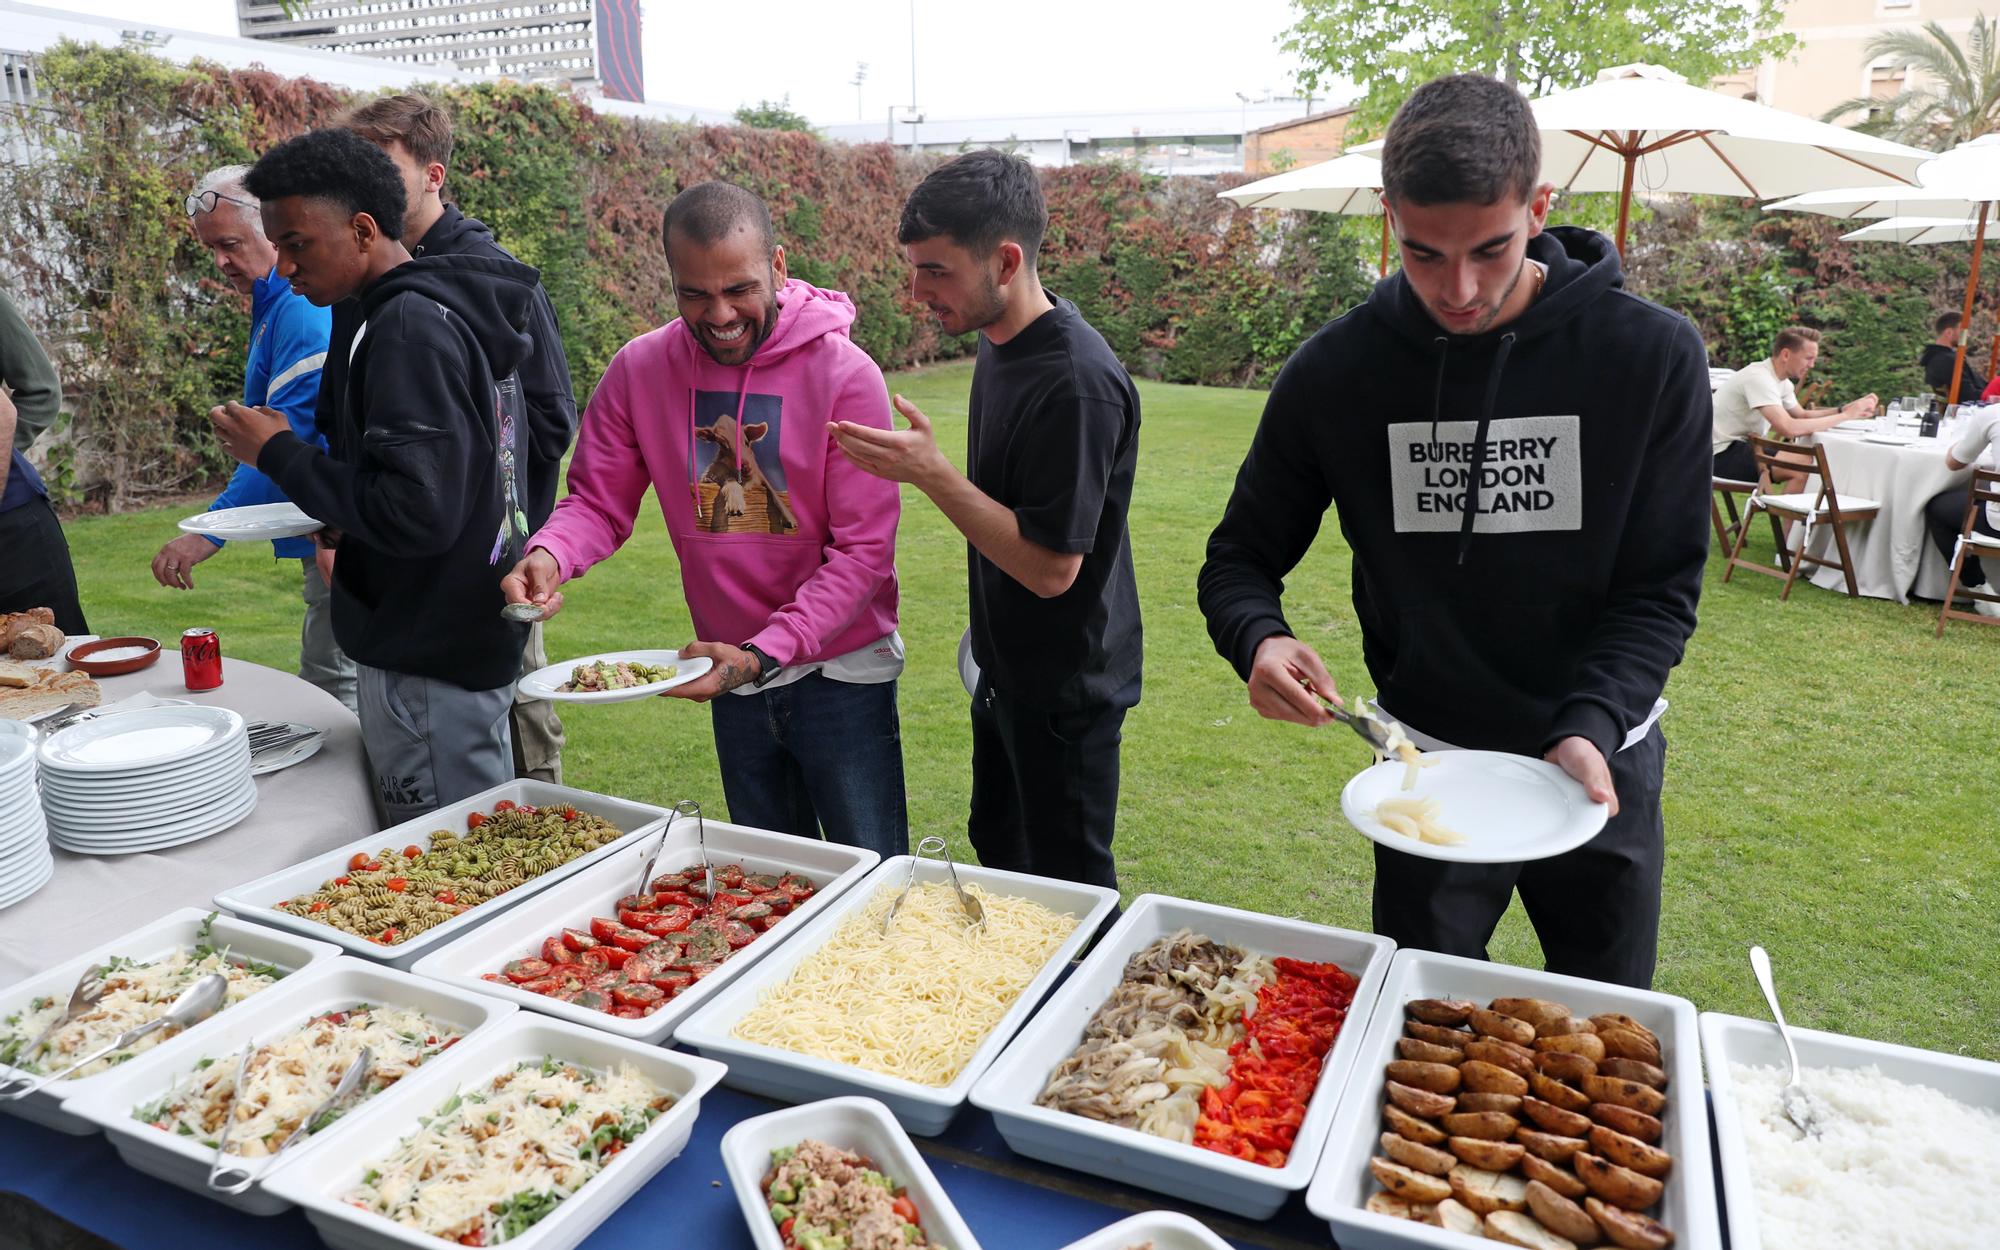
top-left (1200, 74), bottom-right (1710, 986)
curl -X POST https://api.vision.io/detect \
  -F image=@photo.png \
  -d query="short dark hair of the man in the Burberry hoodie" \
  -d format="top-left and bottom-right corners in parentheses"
top-left (1382, 74), bottom-right (1542, 204)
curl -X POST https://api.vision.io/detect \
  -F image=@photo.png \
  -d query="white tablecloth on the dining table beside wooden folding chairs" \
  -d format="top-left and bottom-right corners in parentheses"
top-left (1812, 430), bottom-right (1972, 604)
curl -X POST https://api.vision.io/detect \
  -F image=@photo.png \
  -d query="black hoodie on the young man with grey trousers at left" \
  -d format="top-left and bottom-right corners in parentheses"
top-left (258, 256), bottom-right (536, 690)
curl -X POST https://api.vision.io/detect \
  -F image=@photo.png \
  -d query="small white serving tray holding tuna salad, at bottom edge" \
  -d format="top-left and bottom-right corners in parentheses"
top-left (722, 1096), bottom-right (984, 1250)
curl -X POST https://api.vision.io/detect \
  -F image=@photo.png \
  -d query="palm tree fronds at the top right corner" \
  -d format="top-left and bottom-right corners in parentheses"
top-left (1822, 14), bottom-right (2000, 152)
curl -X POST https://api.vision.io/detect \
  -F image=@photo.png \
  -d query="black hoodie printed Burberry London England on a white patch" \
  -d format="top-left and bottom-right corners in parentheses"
top-left (1200, 228), bottom-right (1712, 758)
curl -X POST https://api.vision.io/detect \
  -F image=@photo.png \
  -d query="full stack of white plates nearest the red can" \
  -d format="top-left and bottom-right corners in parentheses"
top-left (42, 706), bottom-right (256, 856)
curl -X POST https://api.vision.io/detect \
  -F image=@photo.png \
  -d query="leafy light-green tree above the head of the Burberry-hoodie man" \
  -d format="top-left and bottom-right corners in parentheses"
top-left (1282, 0), bottom-right (1796, 134)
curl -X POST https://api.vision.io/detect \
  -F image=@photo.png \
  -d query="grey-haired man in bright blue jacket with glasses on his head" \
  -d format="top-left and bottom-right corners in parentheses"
top-left (152, 166), bottom-right (354, 710)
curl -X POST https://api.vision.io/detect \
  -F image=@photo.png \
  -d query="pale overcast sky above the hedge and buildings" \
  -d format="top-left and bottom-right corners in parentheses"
top-left (58, 0), bottom-right (1328, 124)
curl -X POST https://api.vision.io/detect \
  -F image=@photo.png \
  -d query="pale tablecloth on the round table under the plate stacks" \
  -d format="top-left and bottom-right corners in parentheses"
top-left (0, 650), bottom-right (380, 986)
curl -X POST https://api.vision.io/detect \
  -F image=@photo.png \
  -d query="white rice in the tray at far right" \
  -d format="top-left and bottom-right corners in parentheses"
top-left (1730, 1064), bottom-right (2000, 1250)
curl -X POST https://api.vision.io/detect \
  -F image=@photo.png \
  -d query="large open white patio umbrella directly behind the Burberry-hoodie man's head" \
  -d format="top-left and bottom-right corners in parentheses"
top-left (1358, 64), bottom-right (1930, 256)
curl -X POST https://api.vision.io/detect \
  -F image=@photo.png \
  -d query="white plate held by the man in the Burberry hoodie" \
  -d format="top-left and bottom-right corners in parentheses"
top-left (1340, 750), bottom-right (1610, 864)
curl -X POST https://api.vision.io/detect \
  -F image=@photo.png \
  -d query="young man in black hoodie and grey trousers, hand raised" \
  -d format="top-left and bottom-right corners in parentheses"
top-left (210, 130), bottom-right (536, 822)
